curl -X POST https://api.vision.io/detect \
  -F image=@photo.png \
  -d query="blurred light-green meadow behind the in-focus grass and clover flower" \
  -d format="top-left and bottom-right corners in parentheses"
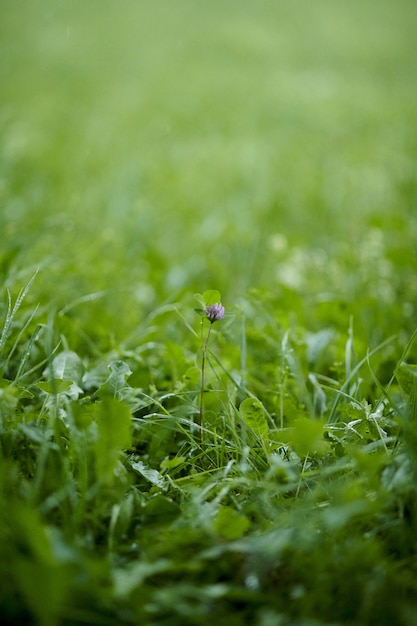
top-left (0, 0), bottom-right (417, 338)
